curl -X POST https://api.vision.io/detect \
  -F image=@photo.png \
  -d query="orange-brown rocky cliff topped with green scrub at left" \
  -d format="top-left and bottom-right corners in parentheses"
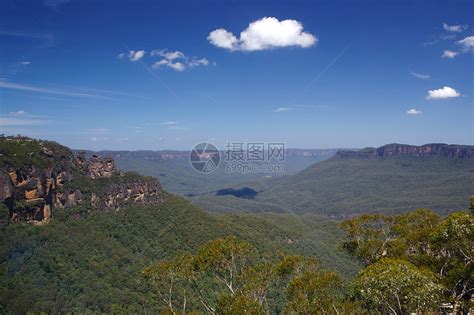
top-left (0, 136), bottom-right (163, 225)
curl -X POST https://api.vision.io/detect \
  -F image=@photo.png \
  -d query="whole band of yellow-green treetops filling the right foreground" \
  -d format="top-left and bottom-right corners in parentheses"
top-left (143, 209), bottom-right (474, 314)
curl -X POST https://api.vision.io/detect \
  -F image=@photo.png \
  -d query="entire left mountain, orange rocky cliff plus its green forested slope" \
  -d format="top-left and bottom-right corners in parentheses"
top-left (0, 137), bottom-right (360, 313)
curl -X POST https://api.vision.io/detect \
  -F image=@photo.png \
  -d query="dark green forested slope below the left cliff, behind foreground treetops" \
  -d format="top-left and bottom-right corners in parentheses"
top-left (0, 195), bottom-right (359, 313)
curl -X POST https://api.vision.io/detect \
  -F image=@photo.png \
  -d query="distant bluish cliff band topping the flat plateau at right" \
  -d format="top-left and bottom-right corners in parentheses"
top-left (336, 143), bottom-right (474, 159)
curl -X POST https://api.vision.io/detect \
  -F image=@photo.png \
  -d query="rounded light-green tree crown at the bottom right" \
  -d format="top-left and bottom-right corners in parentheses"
top-left (352, 258), bottom-right (442, 314)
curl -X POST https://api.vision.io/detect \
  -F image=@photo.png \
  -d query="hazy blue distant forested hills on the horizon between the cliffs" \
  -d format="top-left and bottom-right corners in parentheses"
top-left (74, 149), bottom-right (338, 196)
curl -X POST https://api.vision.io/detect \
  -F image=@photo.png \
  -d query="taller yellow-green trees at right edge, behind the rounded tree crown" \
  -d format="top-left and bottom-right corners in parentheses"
top-left (341, 209), bottom-right (474, 310)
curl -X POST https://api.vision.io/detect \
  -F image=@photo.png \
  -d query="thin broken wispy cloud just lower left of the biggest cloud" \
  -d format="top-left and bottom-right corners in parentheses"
top-left (150, 49), bottom-right (209, 71)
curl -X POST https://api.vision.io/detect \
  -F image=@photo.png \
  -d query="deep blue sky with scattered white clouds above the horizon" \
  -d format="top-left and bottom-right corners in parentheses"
top-left (0, 0), bottom-right (474, 150)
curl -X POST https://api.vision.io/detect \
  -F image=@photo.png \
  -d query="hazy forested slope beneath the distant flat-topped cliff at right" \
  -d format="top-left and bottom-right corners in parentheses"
top-left (197, 156), bottom-right (474, 217)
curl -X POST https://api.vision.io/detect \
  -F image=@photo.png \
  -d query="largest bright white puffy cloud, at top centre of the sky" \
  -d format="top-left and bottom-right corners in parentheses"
top-left (207, 17), bottom-right (318, 51)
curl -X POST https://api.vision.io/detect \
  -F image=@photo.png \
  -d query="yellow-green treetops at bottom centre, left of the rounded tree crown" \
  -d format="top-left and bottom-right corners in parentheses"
top-left (143, 236), bottom-right (360, 314)
